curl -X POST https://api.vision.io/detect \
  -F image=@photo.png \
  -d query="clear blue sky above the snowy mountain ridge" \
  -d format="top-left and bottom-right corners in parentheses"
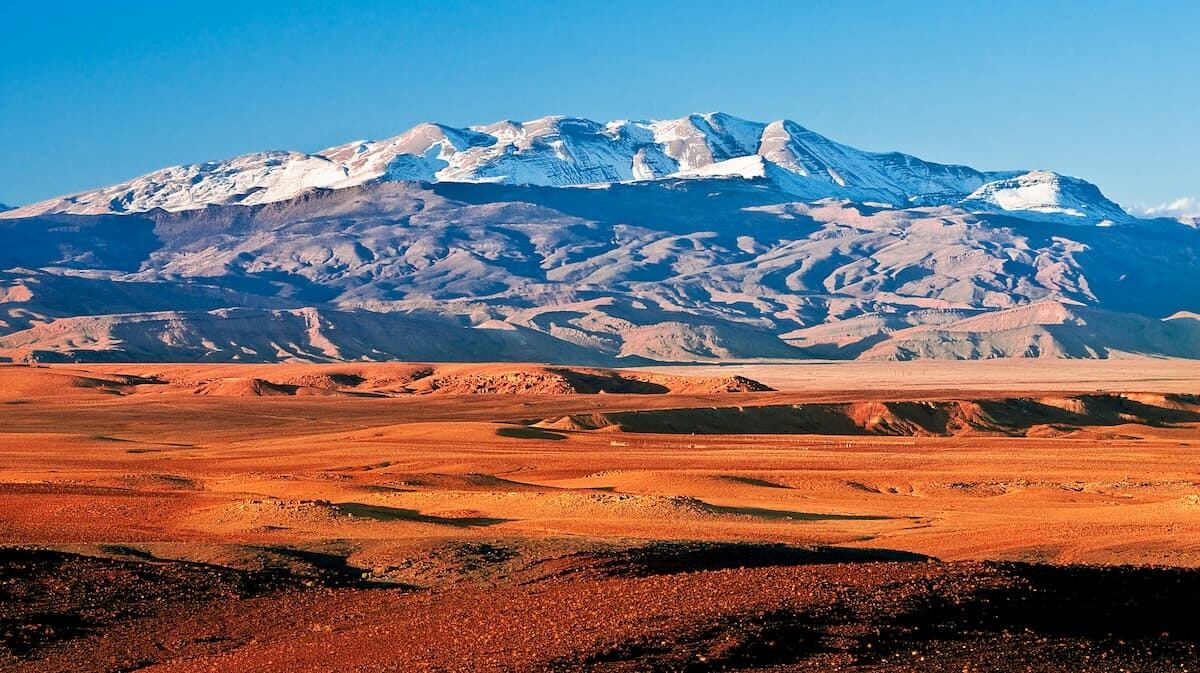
top-left (0, 0), bottom-right (1200, 210)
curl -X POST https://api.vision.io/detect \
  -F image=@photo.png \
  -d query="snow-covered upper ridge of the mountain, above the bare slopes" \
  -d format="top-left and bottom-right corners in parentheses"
top-left (0, 113), bottom-right (1129, 223)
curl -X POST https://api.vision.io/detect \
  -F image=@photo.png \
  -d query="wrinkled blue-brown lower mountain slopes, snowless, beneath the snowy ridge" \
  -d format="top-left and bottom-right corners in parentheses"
top-left (0, 176), bottom-right (1200, 365)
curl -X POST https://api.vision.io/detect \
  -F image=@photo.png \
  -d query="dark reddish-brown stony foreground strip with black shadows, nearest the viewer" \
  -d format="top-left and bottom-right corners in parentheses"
top-left (0, 543), bottom-right (1200, 673)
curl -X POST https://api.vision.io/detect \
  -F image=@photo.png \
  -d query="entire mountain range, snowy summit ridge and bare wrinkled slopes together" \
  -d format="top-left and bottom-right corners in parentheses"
top-left (0, 113), bottom-right (1200, 365)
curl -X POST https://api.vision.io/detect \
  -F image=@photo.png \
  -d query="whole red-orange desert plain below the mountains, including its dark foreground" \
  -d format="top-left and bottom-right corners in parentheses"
top-left (0, 360), bottom-right (1200, 672)
